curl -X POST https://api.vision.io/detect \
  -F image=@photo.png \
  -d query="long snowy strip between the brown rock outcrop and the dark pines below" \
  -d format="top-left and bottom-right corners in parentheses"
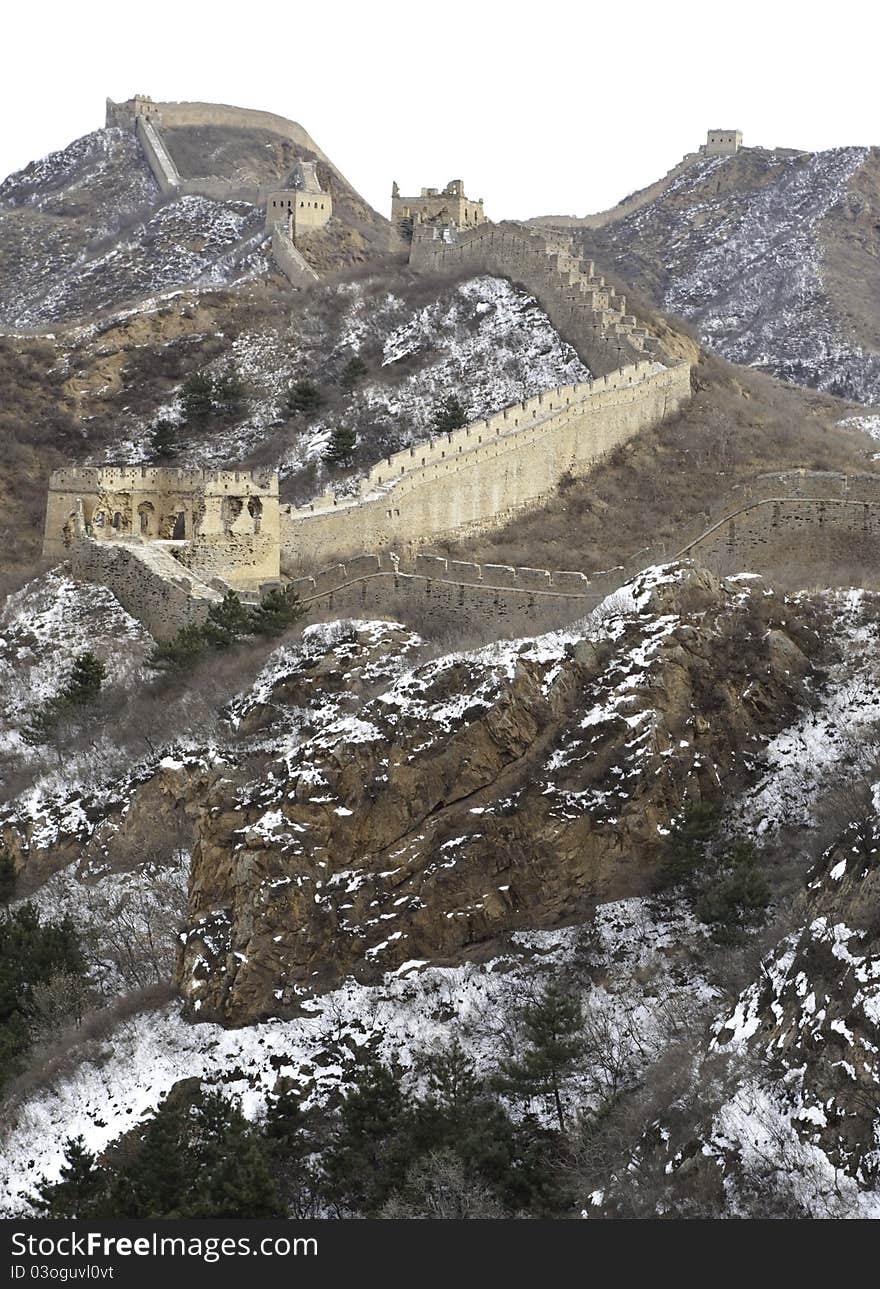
top-left (0, 898), bottom-right (713, 1217)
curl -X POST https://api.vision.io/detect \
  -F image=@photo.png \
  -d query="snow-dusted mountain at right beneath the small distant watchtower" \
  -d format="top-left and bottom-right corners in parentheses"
top-left (546, 147), bottom-right (880, 403)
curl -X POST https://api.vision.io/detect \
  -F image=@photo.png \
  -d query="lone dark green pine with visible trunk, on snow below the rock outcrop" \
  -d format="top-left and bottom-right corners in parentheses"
top-left (497, 981), bottom-right (584, 1132)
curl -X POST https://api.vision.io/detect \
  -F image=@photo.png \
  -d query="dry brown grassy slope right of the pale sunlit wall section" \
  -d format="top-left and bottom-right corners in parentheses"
top-left (438, 353), bottom-right (875, 572)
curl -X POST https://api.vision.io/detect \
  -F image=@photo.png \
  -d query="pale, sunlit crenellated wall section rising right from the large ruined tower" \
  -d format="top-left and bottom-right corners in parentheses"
top-left (281, 362), bottom-right (691, 572)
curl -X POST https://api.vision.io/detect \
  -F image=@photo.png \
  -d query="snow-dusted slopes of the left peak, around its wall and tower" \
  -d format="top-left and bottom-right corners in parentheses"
top-left (0, 119), bottom-right (383, 330)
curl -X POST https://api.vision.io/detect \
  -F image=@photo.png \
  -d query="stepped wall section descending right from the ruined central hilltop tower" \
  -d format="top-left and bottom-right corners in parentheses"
top-left (410, 223), bottom-right (662, 375)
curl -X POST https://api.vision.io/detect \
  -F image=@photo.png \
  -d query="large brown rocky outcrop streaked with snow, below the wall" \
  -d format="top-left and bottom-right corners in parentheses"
top-left (179, 566), bottom-right (834, 1023)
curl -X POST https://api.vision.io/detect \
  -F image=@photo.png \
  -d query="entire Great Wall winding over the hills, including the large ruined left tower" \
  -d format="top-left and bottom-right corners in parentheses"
top-left (44, 99), bottom-right (880, 638)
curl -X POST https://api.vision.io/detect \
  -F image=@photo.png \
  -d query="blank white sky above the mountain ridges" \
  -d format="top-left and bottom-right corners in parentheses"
top-left (0, 0), bottom-right (880, 218)
